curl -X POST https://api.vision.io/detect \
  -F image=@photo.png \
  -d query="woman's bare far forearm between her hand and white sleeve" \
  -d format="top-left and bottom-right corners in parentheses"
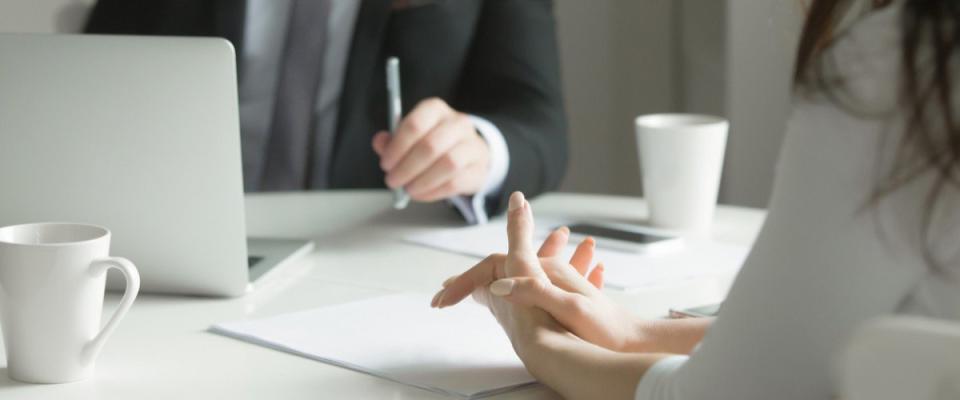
top-left (623, 318), bottom-right (714, 354)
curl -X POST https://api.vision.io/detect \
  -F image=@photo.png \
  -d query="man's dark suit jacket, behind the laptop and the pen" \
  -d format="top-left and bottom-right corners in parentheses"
top-left (86, 0), bottom-right (567, 213)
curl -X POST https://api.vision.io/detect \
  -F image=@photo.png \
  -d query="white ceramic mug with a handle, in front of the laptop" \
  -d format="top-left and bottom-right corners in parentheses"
top-left (0, 223), bottom-right (140, 383)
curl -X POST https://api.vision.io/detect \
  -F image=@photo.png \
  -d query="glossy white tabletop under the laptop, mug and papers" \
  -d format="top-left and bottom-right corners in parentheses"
top-left (0, 190), bottom-right (765, 400)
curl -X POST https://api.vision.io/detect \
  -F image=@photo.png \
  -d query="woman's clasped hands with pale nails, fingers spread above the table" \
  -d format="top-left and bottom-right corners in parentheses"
top-left (432, 193), bottom-right (703, 399)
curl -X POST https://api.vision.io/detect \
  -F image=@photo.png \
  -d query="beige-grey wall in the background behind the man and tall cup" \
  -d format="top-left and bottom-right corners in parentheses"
top-left (0, 0), bottom-right (801, 206)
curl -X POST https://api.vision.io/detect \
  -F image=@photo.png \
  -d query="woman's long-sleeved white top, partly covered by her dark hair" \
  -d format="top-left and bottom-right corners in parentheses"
top-left (636, 6), bottom-right (960, 400)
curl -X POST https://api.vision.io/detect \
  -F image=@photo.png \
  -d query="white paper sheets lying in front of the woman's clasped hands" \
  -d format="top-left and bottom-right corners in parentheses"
top-left (210, 294), bottom-right (535, 399)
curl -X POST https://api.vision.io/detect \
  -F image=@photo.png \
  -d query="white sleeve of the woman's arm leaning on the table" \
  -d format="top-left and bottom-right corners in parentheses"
top-left (636, 7), bottom-right (960, 400)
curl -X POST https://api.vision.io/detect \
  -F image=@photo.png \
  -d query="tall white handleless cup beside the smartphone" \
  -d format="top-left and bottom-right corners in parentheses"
top-left (636, 114), bottom-right (729, 233)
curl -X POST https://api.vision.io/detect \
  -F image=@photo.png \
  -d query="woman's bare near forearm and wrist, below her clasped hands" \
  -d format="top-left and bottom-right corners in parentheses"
top-left (522, 334), bottom-right (668, 400)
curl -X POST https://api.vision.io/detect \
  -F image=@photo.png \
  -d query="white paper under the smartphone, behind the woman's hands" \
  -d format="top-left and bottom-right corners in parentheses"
top-left (404, 218), bottom-right (750, 290)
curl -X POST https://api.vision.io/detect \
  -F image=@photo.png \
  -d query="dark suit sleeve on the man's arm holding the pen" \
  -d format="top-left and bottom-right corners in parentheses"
top-left (454, 0), bottom-right (567, 214)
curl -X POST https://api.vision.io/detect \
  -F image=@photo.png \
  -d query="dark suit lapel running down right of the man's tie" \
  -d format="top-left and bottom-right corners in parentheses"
top-left (334, 0), bottom-right (391, 143)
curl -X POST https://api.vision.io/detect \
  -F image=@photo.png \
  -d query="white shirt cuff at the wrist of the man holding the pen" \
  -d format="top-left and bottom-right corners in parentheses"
top-left (449, 115), bottom-right (510, 225)
